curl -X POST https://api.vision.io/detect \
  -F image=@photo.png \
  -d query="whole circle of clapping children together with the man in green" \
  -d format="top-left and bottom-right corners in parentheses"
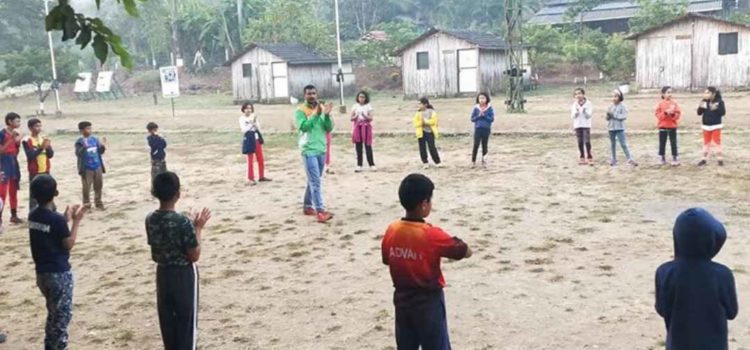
top-left (8, 82), bottom-right (737, 349)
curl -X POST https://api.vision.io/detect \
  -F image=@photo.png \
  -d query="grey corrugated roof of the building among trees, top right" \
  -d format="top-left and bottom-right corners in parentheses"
top-left (529, 0), bottom-right (723, 25)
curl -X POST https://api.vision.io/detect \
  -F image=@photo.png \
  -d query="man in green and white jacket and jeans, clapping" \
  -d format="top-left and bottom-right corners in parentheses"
top-left (294, 85), bottom-right (333, 223)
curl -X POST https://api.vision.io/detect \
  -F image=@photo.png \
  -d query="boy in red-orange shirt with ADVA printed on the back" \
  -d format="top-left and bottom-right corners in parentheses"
top-left (381, 174), bottom-right (472, 350)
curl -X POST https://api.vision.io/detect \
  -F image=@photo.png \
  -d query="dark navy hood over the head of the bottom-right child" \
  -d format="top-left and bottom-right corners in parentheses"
top-left (672, 208), bottom-right (727, 260)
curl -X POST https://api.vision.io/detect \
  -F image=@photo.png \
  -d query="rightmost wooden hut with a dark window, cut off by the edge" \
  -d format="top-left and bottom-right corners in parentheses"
top-left (628, 14), bottom-right (750, 90)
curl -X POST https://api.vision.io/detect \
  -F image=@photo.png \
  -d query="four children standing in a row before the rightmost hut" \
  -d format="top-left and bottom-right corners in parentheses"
top-left (570, 86), bottom-right (726, 166)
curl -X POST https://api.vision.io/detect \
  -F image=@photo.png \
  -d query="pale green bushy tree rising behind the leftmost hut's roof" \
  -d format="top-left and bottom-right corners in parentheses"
top-left (242, 0), bottom-right (336, 53)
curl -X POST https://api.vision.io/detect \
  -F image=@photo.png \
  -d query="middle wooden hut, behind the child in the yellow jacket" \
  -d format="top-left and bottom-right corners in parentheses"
top-left (396, 28), bottom-right (530, 98)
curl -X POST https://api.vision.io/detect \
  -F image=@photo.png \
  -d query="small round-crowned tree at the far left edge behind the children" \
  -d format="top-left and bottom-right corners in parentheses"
top-left (0, 49), bottom-right (78, 114)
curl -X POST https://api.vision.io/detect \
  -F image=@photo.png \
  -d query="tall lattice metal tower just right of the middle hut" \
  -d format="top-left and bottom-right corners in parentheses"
top-left (505, 0), bottom-right (526, 113)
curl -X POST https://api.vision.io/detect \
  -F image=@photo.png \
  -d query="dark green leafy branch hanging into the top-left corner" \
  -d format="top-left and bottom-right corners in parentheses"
top-left (45, 0), bottom-right (146, 68)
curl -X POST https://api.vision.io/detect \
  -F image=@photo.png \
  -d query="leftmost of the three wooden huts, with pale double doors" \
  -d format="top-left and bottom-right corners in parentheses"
top-left (224, 43), bottom-right (356, 103)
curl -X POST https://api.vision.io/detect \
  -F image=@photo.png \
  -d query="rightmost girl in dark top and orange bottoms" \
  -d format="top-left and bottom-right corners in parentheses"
top-left (698, 86), bottom-right (726, 166)
